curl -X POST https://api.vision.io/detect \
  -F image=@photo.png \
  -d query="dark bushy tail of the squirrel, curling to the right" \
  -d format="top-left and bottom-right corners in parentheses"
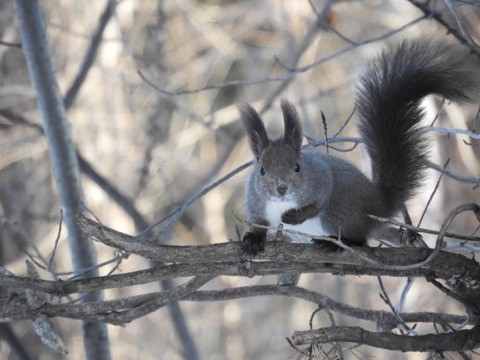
top-left (356, 40), bottom-right (476, 212)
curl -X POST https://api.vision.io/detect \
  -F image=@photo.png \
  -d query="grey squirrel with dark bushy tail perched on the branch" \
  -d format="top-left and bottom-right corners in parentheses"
top-left (239, 39), bottom-right (478, 255)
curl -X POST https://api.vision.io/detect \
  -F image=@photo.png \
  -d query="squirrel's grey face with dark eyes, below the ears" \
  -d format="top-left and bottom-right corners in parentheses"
top-left (253, 140), bottom-right (303, 201)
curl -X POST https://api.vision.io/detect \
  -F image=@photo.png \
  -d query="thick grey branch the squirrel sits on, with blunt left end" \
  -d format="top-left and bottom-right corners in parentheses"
top-left (77, 215), bottom-right (480, 288)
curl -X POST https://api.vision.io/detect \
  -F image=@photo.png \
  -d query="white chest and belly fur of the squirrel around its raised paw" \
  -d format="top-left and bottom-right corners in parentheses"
top-left (265, 201), bottom-right (328, 243)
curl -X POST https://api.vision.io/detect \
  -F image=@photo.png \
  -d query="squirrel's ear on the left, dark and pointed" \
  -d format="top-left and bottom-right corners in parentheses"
top-left (238, 104), bottom-right (270, 161)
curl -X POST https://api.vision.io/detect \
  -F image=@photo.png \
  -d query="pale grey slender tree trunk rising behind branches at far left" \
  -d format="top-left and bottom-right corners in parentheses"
top-left (15, 0), bottom-right (110, 359)
